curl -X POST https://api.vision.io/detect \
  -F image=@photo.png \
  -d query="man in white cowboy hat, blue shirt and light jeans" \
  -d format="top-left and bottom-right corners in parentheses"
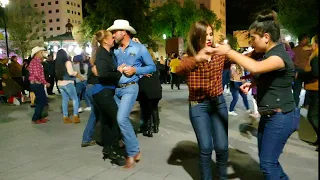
top-left (107, 19), bottom-right (156, 169)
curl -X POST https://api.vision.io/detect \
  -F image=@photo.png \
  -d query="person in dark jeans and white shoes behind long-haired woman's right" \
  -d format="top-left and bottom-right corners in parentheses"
top-left (73, 55), bottom-right (91, 112)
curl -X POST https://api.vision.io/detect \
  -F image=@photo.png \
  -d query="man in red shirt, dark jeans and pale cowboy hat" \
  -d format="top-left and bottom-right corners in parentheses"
top-left (29, 46), bottom-right (50, 124)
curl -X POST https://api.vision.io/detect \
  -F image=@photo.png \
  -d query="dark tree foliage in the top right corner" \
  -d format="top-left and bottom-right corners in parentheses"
top-left (277, 0), bottom-right (319, 36)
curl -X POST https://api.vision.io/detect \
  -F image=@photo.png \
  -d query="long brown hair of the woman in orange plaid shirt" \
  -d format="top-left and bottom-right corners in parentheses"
top-left (187, 21), bottom-right (213, 56)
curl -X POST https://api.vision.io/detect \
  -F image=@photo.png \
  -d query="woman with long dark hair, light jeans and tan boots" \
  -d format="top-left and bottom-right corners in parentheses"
top-left (55, 49), bottom-right (83, 124)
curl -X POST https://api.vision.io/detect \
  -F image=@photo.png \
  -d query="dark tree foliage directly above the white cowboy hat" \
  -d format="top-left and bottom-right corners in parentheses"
top-left (80, 0), bottom-right (157, 49)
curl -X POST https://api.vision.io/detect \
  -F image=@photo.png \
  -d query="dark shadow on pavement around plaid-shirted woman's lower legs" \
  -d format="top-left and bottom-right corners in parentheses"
top-left (167, 141), bottom-right (263, 180)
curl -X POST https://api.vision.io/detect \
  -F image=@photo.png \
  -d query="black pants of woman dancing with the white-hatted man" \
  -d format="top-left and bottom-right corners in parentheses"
top-left (92, 89), bottom-right (120, 147)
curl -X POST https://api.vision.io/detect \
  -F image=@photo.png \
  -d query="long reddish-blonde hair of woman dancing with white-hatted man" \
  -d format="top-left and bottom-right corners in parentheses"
top-left (90, 30), bottom-right (112, 66)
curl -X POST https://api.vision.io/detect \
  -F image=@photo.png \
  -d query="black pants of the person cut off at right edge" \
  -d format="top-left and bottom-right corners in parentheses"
top-left (307, 91), bottom-right (319, 138)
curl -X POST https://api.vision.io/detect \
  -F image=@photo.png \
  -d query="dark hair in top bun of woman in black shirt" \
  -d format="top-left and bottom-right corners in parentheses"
top-left (249, 10), bottom-right (280, 42)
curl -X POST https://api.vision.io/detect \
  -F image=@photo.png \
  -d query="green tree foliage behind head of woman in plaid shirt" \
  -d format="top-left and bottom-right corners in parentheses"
top-left (151, 0), bottom-right (221, 37)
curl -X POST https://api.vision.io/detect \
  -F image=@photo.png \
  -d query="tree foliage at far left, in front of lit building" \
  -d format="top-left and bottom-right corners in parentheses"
top-left (7, 0), bottom-right (45, 57)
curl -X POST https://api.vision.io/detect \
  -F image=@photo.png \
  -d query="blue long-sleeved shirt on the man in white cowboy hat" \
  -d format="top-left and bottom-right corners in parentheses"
top-left (114, 39), bottom-right (156, 84)
